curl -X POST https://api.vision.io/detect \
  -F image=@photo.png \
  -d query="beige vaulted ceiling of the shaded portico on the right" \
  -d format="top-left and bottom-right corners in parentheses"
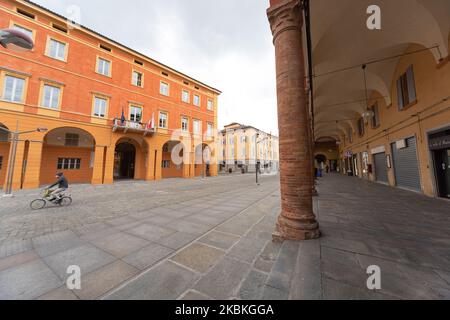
top-left (310, 0), bottom-right (450, 140)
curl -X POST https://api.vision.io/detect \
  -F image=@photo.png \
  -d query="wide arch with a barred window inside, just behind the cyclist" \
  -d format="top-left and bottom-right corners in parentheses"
top-left (39, 127), bottom-right (95, 185)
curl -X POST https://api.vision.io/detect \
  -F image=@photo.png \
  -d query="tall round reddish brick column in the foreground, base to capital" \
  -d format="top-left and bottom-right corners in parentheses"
top-left (267, 0), bottom-right (320, 241)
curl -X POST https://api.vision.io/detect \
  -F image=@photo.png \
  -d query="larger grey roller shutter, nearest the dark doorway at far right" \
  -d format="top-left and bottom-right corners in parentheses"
top-left (392, 138), bottom-right (422, 191)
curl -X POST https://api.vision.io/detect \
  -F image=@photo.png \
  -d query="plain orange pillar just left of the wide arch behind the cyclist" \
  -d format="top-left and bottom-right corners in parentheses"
top-left (23, 141), bottom-right (44, 189)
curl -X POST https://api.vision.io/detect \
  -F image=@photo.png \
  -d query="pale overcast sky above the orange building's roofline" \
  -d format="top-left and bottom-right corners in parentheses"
top-left (35, 0), bottom-right (278, 134)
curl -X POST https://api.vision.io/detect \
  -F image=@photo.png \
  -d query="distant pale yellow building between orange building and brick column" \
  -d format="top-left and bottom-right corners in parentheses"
top-left (217, 123), bottom-right (279, 173)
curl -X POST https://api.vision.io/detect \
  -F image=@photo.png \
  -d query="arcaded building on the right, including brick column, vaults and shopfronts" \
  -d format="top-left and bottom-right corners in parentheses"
top-left (267, 0), bottom-right (450, 240)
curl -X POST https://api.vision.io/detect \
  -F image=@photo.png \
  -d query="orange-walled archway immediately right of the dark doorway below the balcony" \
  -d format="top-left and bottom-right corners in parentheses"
top-left (161, 141), bottom-right (184, 179)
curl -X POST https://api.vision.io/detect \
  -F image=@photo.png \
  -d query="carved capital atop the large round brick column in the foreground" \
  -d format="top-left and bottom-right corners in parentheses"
top-left (267, 0), bottom-right (303, 42)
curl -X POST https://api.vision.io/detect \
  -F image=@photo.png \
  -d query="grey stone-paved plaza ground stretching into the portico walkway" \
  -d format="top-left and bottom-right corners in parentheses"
top-left (0, 175), bottom-right (450, 300)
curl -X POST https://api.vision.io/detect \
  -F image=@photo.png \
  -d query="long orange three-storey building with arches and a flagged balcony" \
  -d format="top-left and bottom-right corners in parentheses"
top-left (0, 0), bottom-right (221, 189)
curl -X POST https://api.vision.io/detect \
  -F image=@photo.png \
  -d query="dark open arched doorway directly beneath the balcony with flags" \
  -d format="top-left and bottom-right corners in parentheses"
top-left (114, 142), bottom-right (136, 180)
